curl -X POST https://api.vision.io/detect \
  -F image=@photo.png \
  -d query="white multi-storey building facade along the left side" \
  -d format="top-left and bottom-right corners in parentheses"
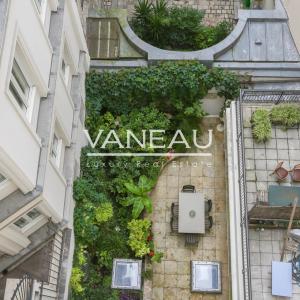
top-left (0, 0), bottom-right (89, 299)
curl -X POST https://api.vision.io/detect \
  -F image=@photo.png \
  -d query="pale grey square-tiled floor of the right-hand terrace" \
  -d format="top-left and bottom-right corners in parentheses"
top-left (243, 105), bottom-right (300, 300)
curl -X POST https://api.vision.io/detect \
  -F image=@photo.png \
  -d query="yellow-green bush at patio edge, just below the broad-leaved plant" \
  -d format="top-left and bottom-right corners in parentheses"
top-left (127, 219), bottom-right (151, 257)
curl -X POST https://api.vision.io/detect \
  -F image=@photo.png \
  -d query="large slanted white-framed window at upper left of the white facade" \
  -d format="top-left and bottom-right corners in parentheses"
top-left (9, 59), bottom-right (30, 112)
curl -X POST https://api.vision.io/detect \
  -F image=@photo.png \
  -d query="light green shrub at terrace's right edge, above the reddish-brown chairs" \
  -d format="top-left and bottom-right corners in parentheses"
top-left (270, 104), bottom-right (300, 129)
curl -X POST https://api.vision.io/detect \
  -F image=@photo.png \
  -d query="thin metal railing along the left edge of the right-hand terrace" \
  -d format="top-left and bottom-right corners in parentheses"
top-left (236, 96), bottom-right (252, 300)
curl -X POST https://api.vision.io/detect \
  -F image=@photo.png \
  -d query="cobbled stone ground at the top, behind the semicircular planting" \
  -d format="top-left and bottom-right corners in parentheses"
top-left (87, 0), bottom-right (241, 25)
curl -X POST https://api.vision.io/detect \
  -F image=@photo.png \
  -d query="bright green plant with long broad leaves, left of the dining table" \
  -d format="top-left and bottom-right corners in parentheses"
top-left (122, 175), bottom-right (155, 219)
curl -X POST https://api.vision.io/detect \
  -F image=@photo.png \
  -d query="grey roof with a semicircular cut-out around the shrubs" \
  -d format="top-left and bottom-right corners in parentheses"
top-left (89, 0), bottom-right (300, 78)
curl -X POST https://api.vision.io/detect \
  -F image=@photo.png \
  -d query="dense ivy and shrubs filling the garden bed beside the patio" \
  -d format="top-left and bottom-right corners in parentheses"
top-left (71, 61), bottom-right (239, 299)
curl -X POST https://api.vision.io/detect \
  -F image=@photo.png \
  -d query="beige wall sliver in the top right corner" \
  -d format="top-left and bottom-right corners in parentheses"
top-left (282, 0), bottom-right (300, 51)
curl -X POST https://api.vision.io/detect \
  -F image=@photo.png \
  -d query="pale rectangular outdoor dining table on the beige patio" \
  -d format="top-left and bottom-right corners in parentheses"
top-left (178, 192), bottom-right (205, 233)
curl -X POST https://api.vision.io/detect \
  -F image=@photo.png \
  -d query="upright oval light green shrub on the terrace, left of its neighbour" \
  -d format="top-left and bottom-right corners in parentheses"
top-left (251, 109), bottom-right (272, 143)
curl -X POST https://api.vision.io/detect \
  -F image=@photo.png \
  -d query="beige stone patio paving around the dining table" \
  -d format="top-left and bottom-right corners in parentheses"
top-left (144, 117), bottom-right (230, 300)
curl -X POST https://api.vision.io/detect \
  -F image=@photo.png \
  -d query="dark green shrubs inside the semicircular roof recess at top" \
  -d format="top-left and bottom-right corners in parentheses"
top-left (131, 0), bottom-right (232, 50)
